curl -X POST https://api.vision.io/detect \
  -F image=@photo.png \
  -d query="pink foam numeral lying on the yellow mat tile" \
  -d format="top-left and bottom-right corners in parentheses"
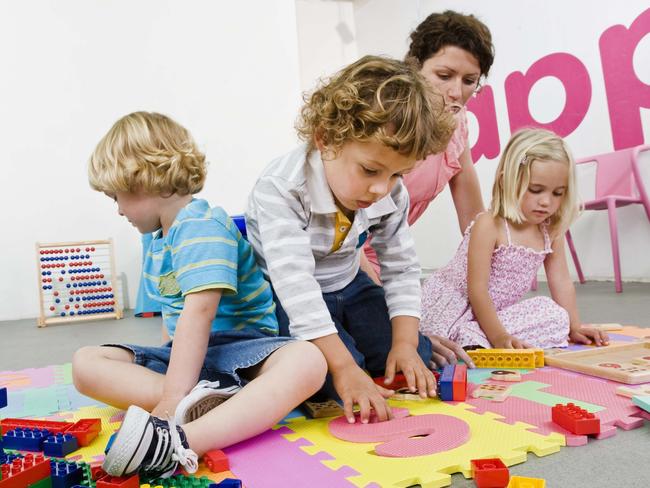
top-left (328, 408), bottom-right (469, 457)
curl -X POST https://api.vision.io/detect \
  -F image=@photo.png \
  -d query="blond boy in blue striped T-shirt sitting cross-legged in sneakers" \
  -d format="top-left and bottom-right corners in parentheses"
top-left (73, 112), bottom-right (326, 478)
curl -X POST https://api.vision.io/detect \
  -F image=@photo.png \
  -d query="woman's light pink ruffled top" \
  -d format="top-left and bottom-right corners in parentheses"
top-left (363, 107), bottom-right (468, 274)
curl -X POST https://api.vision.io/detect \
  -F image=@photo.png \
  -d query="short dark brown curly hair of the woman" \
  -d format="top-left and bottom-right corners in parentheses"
top-left (406, 10), bottom-right (494, 76)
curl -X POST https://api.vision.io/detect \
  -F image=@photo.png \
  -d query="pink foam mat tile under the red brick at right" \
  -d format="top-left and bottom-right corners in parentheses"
top-left (467, 367), bottom-right (648, 446)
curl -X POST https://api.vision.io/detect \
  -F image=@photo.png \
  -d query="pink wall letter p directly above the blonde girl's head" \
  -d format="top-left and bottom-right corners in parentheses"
top-left (505, 53), bottom-right (591, 137)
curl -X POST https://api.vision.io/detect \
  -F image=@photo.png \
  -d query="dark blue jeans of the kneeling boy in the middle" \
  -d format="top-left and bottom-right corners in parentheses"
top-left (273, 270), bottom-right (432, 400)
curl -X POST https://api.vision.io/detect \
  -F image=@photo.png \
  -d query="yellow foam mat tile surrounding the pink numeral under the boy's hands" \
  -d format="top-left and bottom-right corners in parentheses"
top-left (285, 399), bottom-right (565, 488)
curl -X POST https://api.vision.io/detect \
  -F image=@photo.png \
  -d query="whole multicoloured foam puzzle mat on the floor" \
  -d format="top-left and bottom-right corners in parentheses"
top-left (0, 326), bottom-right (650, 488)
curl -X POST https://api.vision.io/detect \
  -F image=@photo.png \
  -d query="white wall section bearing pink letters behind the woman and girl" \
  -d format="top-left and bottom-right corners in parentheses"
top-left (354, 0), bottom-right (650, 281)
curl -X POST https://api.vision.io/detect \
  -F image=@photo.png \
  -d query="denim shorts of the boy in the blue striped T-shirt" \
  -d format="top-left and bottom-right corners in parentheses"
top-left (104, 329), bottom-right (295, 387)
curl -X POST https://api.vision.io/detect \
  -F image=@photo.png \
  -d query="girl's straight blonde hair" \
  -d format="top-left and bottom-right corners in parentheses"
top-left (491, 129), bottom-right (580, 237)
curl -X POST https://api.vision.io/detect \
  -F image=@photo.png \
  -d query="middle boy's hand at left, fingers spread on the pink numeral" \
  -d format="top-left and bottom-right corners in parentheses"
top-left (332, 363), bottom-right (395, 424)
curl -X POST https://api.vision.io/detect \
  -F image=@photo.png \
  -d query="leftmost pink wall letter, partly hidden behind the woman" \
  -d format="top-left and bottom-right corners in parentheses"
top-left (467, 86), bottom-right (501, 162)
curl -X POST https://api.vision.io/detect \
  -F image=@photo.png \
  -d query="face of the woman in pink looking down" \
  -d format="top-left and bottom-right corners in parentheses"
top-left (420, 46), bottom-right (481, 113)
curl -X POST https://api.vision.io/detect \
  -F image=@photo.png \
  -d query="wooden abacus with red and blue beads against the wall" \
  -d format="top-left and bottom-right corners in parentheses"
top-left (36, 240), bottom-right (122, 327)
